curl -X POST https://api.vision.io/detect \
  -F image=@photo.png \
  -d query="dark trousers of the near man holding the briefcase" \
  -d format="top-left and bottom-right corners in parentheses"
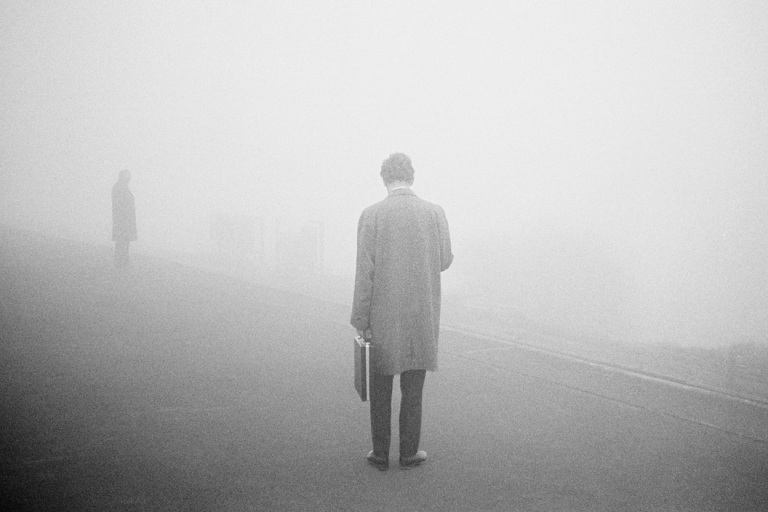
top-left (371, 370), bottom-right (427, 458)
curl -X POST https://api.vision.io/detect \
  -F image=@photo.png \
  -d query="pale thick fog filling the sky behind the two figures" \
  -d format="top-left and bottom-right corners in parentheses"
top-left (0, 0), bottom-right (768, 345)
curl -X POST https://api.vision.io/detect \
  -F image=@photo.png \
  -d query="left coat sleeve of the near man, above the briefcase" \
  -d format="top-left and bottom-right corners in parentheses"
top-left (350, 212), bottom-right (376, 331)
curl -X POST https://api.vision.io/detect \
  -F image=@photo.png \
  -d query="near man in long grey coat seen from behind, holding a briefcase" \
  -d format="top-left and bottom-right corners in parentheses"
top-left (351, 153), bottom-right (453, 471)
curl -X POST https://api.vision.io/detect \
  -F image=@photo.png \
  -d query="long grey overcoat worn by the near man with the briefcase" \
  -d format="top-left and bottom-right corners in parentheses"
top-left (351, 188), bottom-right (453, 375)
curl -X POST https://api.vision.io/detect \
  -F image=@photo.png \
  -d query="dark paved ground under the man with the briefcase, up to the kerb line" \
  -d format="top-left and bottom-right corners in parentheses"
top-left (0, 230), bottom-right (768, 511)
